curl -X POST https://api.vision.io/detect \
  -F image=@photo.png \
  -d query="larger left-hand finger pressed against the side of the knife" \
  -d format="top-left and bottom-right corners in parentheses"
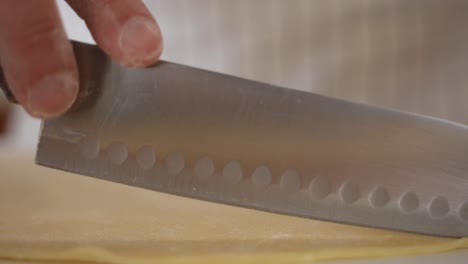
top-left (0, 0), bottom-right (78, 118)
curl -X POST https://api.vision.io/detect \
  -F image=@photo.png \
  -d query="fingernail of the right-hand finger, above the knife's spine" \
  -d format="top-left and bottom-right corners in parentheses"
top-left (120, 17), bottom-right (162, 66)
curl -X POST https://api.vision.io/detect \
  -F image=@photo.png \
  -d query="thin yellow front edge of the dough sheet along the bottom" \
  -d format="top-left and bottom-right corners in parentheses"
top-left (0, 238), bottom-right (468, 264)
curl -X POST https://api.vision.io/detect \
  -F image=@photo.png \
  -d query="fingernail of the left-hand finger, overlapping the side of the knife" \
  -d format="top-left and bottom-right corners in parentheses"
top-left (26, 73), bottom-right (78, 118)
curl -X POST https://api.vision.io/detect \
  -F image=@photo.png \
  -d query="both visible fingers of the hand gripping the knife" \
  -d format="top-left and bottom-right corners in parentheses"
top-left (0, 0), bottom-right (163, 119)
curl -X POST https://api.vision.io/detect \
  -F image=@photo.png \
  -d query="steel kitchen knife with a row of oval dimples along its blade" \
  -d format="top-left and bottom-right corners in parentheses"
top-left (1, 42), bottom-right (468, 237)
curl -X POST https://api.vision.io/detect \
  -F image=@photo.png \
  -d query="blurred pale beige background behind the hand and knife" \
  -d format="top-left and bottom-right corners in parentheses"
top-left (0, 0), bottom-right (468, 156)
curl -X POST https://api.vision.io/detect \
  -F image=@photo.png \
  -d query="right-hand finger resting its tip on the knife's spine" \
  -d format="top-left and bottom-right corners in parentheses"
top-left (67, 0), bottom-right (163, 66)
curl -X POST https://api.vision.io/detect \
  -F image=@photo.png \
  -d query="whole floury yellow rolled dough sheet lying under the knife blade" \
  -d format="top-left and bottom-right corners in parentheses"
top-left (0, 157), bottom-right (468, 264)
